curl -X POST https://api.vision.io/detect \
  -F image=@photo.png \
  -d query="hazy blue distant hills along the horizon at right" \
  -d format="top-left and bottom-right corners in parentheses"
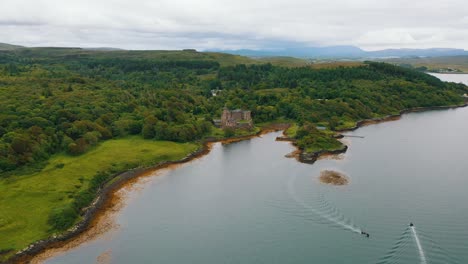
top-left (210, 46), bottom-right (468, 59)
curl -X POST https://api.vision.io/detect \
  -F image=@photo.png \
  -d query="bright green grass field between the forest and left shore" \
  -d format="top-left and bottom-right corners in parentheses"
top-left (0, 137), bottom-right (200, 262)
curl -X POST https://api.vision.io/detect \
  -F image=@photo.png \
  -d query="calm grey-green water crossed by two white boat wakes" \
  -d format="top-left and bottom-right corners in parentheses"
top-left (48, 75), bottom-right (468, 264)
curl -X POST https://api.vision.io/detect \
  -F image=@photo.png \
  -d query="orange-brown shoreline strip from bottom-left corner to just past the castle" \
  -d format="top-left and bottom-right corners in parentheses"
top-left (8, 124), bottom-right (288, 264)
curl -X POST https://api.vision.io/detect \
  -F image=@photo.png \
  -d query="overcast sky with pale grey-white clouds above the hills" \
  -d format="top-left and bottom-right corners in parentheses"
top-left (0, 0), bottom-right (468, 50)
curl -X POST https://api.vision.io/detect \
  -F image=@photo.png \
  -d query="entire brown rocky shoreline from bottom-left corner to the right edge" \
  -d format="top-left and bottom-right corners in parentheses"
top-left (5, 103), bottom-right (468, 264)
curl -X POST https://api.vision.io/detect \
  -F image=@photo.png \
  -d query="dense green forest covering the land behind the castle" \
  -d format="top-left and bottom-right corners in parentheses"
top-left (0, 49), bottom-right (468, 172)
